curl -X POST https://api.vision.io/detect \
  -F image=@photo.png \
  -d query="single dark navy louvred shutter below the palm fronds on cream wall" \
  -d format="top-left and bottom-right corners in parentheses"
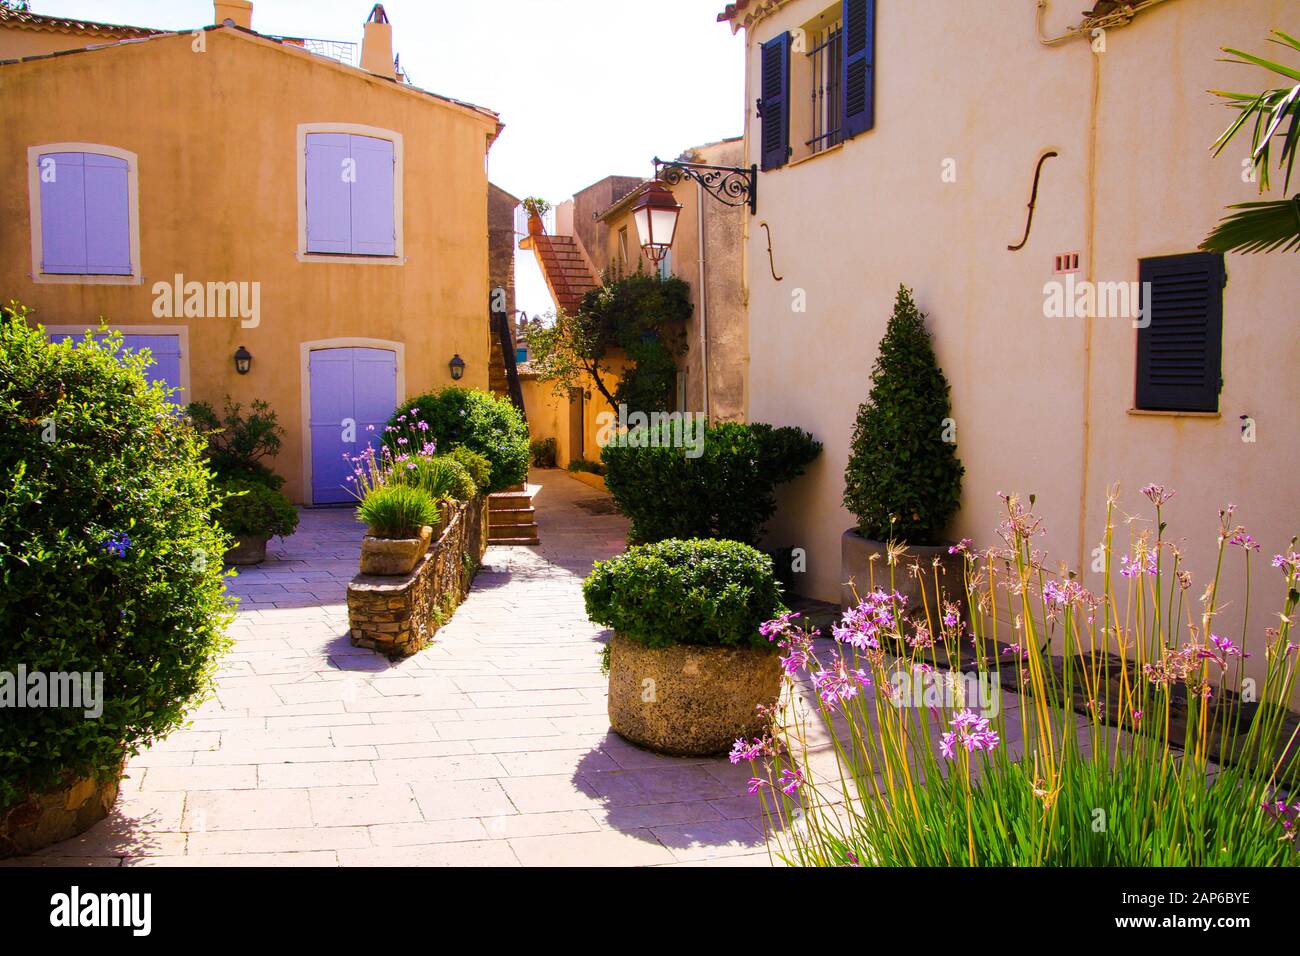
top-left (1136, 252), bottom-right (1225, 411)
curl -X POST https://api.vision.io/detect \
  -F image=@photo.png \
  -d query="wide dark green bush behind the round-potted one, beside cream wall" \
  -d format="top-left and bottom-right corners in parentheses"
top-left (601, 421), bottom-right (822, 544)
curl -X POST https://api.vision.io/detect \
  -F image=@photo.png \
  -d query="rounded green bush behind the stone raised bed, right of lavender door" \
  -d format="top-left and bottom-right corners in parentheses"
top-left (389, 386), bottom-right (528, 493)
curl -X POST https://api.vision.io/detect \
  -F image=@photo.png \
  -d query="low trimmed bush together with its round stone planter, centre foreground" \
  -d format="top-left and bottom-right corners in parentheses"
top-left (582, 538), bottom-right (785, 756)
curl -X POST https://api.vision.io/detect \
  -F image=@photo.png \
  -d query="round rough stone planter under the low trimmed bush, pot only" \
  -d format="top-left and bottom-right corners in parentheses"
top-left (610, 633), bottom-right (781, 757)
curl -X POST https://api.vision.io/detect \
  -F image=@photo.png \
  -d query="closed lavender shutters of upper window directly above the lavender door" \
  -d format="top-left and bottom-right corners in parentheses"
top-left (300, 127), bottom-right (400, 258)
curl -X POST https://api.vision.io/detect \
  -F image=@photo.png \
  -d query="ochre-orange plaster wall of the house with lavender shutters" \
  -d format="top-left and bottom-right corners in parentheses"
top-left (0, 29), bottom-right (497, 501)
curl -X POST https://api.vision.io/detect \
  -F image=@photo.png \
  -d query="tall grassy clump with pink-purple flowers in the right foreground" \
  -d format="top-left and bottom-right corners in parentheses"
top-left (732, 485), bottom-right (1300, 866)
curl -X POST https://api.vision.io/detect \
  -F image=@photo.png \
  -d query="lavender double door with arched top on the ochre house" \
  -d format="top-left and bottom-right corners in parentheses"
top-left (308, 349), bottom-right (398, 505)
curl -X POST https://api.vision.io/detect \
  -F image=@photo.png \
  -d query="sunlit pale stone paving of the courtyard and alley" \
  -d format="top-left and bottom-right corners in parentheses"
top-left (16, 471), bottom-right (768, 866)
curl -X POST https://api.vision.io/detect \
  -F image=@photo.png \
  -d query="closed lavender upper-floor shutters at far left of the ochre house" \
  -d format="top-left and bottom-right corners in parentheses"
top-left (35, 151), bottom-right (133, 276)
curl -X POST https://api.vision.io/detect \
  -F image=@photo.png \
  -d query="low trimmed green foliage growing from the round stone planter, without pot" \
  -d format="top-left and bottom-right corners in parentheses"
top-left (582, 538), bottom-right (785, 649)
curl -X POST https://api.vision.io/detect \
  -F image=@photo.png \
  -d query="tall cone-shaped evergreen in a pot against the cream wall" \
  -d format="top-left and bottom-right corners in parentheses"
top-left (841, 286), bottom-right (965, 609)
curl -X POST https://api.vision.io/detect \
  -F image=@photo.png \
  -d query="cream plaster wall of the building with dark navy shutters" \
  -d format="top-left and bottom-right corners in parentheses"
top-left (746, 0), bottom-right (1300, 691)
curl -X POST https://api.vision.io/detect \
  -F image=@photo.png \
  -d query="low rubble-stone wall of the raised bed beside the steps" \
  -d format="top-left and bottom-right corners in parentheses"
top-left (347, 496), bottom-right (488, 658)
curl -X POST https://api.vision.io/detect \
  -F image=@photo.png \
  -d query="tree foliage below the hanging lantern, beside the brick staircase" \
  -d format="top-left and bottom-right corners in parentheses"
top-left (527, 272), bottom-right (693, 411)
